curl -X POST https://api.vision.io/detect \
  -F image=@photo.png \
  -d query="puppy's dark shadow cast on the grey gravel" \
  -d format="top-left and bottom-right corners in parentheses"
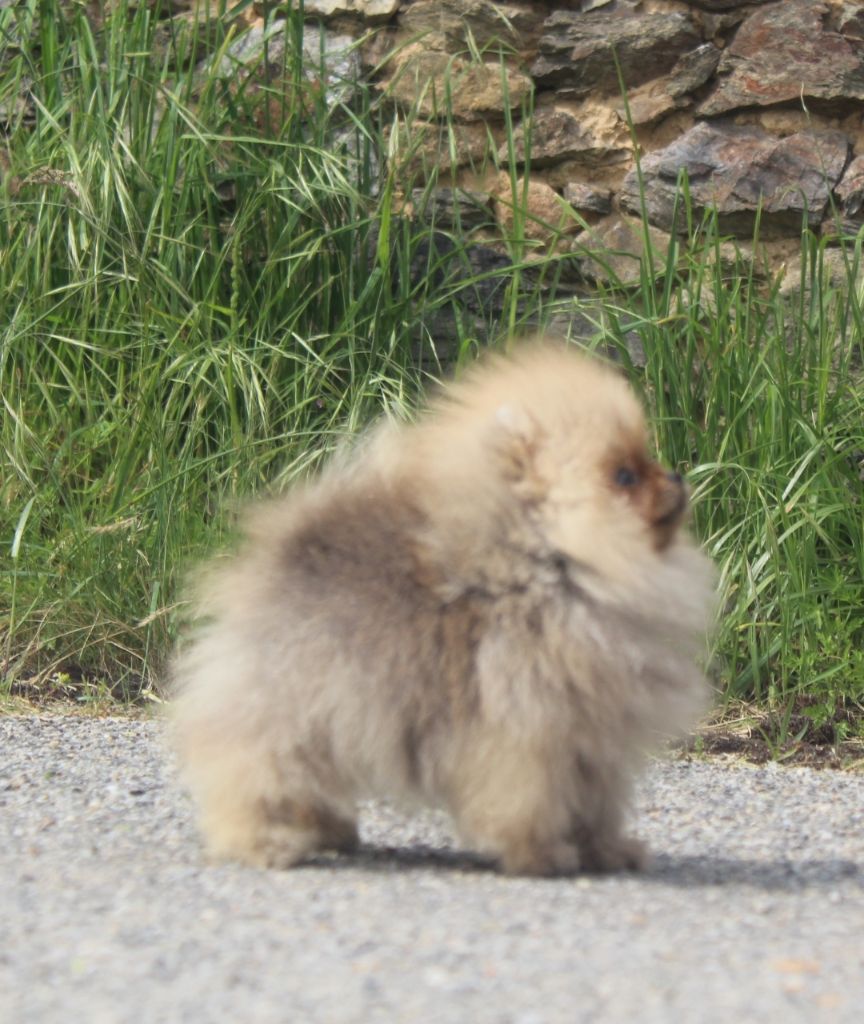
top-left (303, 844), bottom-right (864, 892)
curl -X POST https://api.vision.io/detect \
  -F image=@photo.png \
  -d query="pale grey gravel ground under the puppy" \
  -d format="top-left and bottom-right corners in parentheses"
top-left (0, 718), bottom-right (864, 1024)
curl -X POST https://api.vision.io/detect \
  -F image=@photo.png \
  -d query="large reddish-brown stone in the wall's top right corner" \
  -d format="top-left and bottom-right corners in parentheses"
top-left (699, 0), bottom-right (864, 117)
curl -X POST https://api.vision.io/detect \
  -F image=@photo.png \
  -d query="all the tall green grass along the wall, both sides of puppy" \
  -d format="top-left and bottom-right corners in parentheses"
top-left (0, 0), bottom-right (864, 729)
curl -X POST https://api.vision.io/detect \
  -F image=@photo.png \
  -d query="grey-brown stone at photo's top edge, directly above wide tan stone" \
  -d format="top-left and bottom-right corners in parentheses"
top-left (399, 0), bottom-right (543, 52)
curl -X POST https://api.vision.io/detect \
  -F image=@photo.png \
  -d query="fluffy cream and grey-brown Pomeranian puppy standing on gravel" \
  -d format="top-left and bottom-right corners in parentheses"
top-left (174, 340), bottom-right (714, 874)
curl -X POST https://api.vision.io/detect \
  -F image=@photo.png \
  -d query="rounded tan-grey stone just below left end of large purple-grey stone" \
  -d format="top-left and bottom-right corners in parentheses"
top-left (574, 214), bottom-right (672, 286)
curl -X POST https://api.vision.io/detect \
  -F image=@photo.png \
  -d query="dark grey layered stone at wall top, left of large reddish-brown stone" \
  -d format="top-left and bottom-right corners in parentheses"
top-left (531, 9), bottom-right (702, 96)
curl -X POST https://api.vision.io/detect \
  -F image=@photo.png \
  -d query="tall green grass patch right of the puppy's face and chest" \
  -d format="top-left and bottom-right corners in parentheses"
top-left (606, 223), bottom-right (864, 731)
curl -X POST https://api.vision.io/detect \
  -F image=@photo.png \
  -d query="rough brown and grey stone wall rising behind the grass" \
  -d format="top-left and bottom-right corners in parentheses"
top-left (290, 0), bottom-right (864, 284)
